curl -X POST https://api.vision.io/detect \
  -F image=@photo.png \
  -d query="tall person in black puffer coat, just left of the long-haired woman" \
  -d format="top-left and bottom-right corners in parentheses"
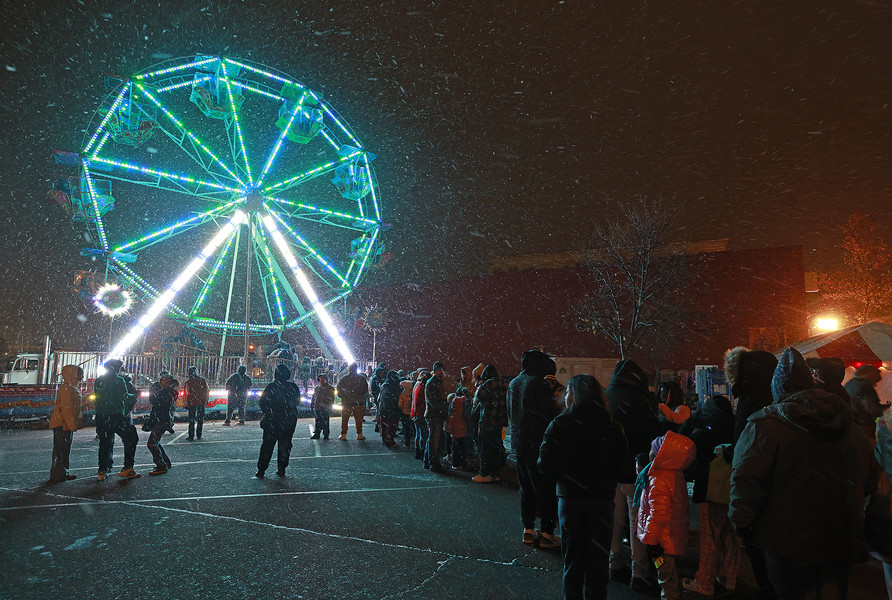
top-left (507, 350), bottom-right (560, 548)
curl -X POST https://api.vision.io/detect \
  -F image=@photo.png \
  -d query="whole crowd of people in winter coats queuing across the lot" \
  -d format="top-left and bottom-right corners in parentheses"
top-left (50, 347), bottom-right (892, 600)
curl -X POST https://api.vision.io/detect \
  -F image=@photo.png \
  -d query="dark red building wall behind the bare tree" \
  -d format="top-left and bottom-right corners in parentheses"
top-left (348, 247), bottom-right (806, 383)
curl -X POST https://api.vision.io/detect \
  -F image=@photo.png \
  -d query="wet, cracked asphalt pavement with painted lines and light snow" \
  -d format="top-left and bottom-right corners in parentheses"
top-left (0, 419), bottom-right (882, 600)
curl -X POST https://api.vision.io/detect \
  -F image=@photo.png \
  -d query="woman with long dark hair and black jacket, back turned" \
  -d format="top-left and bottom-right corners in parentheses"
top-left (538, 375), bottom-right (634, 600)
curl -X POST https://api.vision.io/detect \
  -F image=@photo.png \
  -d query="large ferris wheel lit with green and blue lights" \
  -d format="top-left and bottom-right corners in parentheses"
top-left (66, 55), bottom-right (389, 358)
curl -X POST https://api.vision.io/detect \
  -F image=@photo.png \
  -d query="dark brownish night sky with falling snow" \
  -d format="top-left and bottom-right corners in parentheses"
top-left (0, 0), bottom-right (892, 348)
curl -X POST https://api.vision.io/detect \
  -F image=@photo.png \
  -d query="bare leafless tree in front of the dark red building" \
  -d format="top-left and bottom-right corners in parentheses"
top-left (572, 197), bottom-right (690, 358)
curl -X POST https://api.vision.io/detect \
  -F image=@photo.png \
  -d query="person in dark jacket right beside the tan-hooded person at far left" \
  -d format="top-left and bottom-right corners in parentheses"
top-left (93, 358), bottom-right (139, 481)
